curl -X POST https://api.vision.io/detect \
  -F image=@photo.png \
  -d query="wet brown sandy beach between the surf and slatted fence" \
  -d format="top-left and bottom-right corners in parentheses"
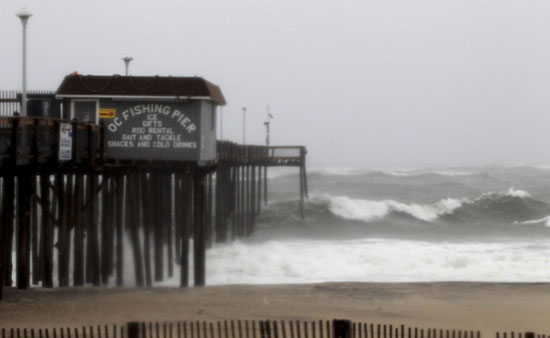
top-left (0, 282), bottom-right (550, 336)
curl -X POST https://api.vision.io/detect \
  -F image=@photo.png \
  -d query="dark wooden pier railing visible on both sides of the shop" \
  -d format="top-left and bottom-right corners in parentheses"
top-left (0, 116), bottom-right (307, 171)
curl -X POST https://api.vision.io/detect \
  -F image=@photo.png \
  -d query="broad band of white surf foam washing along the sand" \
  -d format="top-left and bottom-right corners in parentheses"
top-left (152, 239), bottom-right (550, 286)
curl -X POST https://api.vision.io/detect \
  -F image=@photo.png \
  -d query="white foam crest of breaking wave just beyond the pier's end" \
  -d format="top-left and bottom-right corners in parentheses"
top-left (313, 194), bottom-right (463, 222)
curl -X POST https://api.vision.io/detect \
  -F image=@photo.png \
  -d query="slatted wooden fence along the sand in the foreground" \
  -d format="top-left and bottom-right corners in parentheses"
top-left (1, 319), bottom-right (547, 338)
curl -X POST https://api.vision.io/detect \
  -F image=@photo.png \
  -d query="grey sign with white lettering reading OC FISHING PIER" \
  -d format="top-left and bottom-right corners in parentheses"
top-left (102, 102), bottom-right (201, 161)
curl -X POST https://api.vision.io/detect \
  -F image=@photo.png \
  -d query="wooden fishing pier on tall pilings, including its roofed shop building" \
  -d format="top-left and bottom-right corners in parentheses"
top-left (0, 74), bottom-right (307, 297)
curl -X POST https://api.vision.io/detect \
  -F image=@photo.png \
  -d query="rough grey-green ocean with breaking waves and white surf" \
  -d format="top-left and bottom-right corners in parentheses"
top-left (195, 166), bottom-right (550, 285)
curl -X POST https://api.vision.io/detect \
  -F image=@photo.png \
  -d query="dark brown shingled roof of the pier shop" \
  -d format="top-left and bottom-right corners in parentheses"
top-left (56, 74), bottom-right (226, 105)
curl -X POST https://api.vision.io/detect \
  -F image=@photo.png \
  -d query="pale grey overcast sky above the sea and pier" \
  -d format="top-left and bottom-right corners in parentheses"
top-left (0, 0), bottom-right (550, 167)
